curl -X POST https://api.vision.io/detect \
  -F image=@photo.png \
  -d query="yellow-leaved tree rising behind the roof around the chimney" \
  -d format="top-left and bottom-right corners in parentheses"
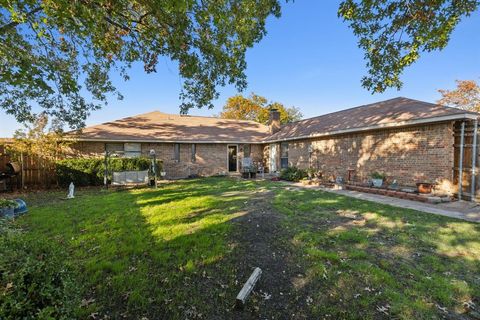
top-left (220, 93), bottom-right (303, 124)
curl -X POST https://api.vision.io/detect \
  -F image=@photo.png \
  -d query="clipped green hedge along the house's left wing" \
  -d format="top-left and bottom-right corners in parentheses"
top-left (55, 157), bottom-right (162, 186)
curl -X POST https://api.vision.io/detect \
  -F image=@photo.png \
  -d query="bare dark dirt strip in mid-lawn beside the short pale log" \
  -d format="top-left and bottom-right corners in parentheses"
top-left (228, 190), bottom-right (308, 319)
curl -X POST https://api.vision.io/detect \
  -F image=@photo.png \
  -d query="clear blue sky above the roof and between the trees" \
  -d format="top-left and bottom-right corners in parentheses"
top-left (0, 0), bottom-right (480, 137)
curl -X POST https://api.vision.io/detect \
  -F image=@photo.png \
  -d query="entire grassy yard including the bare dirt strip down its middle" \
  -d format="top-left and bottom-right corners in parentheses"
top-left (1, 178), bottom-right (480, 319)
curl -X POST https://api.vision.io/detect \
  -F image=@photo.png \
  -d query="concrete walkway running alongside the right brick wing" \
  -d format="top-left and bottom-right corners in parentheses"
top-left (289, 183), bottom-right (480, 223)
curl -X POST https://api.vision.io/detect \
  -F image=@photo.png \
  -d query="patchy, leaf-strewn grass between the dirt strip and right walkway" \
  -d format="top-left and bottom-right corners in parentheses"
top-left (274, 190), bottom-right (480, 319)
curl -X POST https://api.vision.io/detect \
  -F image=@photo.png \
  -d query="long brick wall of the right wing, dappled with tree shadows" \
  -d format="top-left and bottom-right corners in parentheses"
top-left (278, 123), bottom-right (454, 185)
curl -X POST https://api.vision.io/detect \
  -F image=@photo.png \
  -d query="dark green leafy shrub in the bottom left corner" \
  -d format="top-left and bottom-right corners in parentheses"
top-left (0, 220), bottom-right (80, 319)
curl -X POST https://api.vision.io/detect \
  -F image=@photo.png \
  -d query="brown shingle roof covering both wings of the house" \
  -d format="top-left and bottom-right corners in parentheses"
top-left (73, 97), bottom-right (479, 143)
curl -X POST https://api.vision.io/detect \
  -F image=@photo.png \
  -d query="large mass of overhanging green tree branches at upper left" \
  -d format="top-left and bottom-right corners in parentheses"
top-left (0, 0), bottom-right (280, 128)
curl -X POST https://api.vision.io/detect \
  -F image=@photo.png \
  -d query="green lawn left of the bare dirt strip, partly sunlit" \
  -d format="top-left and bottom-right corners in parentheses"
top-left (19, 178), bottom-right (266, 319)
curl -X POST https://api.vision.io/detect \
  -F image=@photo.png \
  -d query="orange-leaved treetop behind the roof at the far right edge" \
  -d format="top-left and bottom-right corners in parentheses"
top-left (437, 80), bottom-right (480, 112)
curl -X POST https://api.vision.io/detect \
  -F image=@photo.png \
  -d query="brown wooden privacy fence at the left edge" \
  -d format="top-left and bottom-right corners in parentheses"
top-left (0, 145), bottom-right (57, 189)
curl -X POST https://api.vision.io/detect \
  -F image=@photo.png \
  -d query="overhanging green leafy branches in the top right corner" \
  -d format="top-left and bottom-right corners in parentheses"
top-left (338, 0), bottom-right (480, 92)
